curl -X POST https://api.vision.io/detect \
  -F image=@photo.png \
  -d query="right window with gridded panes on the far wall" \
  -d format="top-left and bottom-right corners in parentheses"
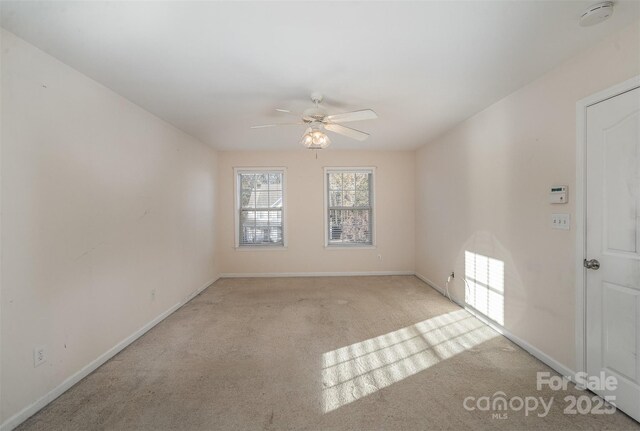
top-left (325, 168), bottom-right (374, 246)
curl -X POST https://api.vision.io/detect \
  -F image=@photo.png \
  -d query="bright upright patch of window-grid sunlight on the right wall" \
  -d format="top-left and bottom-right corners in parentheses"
top-left (464, 251), bottom-right (504, 325)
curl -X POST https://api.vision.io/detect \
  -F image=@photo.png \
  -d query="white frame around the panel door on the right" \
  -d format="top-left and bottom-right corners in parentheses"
top-left (575, 75), bottom-right (640, 372)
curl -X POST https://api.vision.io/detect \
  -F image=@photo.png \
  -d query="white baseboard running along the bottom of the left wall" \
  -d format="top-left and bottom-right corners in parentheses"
top-left (0, 277), bottom-right (220, 431)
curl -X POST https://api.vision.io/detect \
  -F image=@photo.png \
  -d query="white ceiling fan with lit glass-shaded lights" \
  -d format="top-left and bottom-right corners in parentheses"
top-left (251, 93), bottom-right (378, 150)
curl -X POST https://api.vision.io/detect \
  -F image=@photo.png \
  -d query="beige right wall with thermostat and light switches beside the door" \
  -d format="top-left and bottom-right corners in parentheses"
top-left (416, 24), bottom-right (640, 369)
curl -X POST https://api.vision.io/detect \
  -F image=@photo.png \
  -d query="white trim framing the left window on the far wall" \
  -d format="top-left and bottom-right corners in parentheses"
top-left (233, 166), bottom-right (289, 251)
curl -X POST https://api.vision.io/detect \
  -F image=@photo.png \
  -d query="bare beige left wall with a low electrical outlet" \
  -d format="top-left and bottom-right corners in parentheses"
top-left (0, 31), bottom-right (217, 422)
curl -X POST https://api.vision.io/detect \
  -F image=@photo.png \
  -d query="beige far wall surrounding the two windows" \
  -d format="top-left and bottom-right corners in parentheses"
top-left (218, 149), bottom-right (415, 274)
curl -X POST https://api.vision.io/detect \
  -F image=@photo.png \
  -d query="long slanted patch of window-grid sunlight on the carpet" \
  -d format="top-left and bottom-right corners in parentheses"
top-left (322, 310), bottom-right (498, 413)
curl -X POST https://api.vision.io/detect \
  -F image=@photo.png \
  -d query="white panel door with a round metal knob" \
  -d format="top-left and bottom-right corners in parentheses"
top-left (585, 88), bottom-right (640, 421)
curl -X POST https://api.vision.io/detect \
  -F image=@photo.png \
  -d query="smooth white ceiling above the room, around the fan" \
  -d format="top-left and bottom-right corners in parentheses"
top-left (0, 0), bottom-right (640, 150)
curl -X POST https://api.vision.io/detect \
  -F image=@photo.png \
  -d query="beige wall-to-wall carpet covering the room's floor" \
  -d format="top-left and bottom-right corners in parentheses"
top-left (20, 276), bottom-right (640, 430)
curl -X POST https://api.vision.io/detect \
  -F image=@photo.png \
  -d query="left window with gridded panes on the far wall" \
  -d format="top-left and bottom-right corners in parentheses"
top-left (235, 169), bottom-right (285, 247)
